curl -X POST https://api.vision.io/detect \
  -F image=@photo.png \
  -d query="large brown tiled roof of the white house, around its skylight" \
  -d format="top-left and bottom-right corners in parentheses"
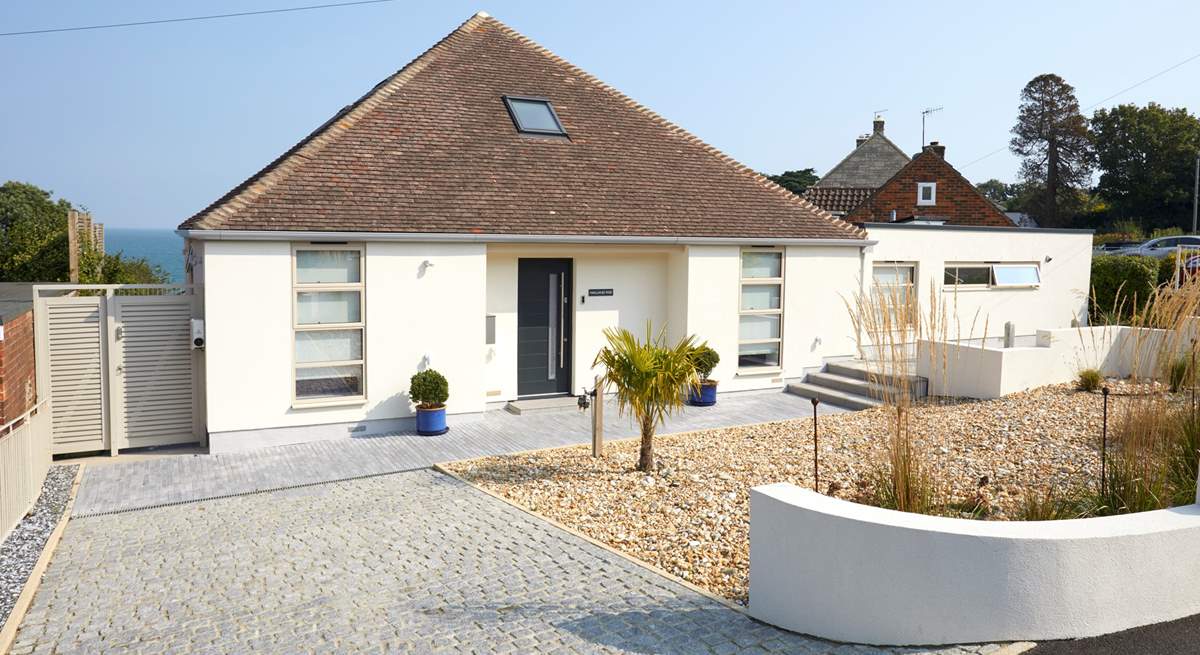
top-left (180, 13), bottom-right (865, 239)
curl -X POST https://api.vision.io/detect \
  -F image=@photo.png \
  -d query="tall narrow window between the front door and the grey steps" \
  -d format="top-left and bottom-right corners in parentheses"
top-left (738, 250), bottom-right (784, 371)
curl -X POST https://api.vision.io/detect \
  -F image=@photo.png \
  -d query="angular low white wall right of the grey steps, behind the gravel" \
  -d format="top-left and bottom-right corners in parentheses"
top-left (916, 326), bottom-right (1190, 398)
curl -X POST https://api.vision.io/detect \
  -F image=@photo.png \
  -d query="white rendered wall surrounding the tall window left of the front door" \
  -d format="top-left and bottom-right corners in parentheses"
top-left (204, 241), bottom-right (486, 450)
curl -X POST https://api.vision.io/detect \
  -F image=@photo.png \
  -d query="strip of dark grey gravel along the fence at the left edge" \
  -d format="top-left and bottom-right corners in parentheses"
top-left (0, 465), bottom-right (79, 625)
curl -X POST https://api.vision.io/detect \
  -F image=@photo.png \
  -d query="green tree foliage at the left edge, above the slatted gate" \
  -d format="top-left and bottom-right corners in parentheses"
top-left (0, 181), bottom-right (168, 284)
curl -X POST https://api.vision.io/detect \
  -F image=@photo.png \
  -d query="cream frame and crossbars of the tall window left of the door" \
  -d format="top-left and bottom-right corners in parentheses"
top-left (289, 244), bottom-right (367, 408)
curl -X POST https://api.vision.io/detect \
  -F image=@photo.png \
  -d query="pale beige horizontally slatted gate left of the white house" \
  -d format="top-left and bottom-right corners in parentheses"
top-left (35, 284), bottom-right (204, 455)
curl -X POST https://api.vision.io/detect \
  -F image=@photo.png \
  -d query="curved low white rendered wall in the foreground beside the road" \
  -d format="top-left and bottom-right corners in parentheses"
top-left (750, 483), bottom-right (1200, 645)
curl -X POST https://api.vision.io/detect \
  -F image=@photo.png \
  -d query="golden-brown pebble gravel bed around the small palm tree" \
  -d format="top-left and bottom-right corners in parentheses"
top-left (448, 380), bottom-right (1147, 603)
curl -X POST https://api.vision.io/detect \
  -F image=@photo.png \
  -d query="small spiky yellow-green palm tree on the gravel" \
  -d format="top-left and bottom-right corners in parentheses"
top-left (592, 323), bottom-right (700, 473)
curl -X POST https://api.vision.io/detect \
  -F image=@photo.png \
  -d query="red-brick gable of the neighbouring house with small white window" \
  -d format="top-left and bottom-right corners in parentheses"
top-left (845, 145), bottom-right (1014, 228)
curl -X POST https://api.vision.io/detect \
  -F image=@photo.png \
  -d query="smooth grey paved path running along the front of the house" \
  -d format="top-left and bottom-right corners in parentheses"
top-left (73, 391), bottom-right (842, 516)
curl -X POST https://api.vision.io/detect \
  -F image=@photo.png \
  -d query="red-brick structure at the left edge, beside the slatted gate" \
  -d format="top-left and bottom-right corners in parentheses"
top-left (0, 282), bottom-right (37, 425)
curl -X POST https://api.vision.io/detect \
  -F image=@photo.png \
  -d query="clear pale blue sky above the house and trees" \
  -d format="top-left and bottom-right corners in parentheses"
top-left (0, 0), bottom-right (1200, 229)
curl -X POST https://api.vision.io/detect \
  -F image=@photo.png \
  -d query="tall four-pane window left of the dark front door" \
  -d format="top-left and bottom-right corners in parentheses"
top-left (292, 245), bottom-right (366, 404)
